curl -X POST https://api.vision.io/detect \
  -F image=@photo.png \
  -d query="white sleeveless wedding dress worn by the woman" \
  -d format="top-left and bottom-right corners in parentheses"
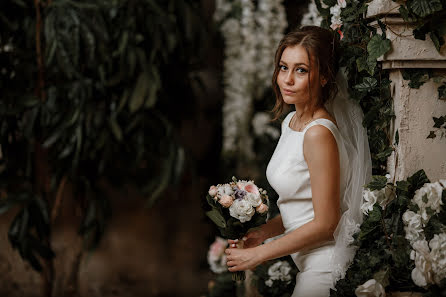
top-left (266, 111), bottom-right (349, 297)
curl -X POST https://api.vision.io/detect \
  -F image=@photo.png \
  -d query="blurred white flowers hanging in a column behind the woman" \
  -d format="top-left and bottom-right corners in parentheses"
top-left (214, 0), bottom-right (287, 158)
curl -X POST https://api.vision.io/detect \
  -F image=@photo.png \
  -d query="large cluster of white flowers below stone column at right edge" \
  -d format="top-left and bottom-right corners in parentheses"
top-left (403, 180), bottom-right (446, 287)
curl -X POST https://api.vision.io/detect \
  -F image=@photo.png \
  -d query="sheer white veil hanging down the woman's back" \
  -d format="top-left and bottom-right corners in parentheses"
top-left (325, 68), bottom-right (372, 286)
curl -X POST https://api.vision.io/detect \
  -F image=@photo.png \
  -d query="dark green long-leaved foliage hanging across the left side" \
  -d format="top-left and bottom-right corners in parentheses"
top-left (0, 0), bottom-right (203, 269)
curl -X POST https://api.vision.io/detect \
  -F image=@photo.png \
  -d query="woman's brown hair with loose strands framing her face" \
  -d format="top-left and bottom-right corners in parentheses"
top-left (272, 26), bottom-right (339, 120)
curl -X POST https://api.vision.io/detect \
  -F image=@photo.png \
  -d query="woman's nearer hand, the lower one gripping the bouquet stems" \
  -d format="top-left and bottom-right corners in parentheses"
top-left (225, 248), bottom-right (263, 272)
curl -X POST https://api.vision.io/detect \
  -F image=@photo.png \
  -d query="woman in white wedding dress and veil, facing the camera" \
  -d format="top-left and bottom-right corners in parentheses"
top-left (225, 26), bottom-right (371, 297)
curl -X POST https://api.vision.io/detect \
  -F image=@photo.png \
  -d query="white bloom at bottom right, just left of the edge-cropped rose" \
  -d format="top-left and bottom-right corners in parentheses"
top-left (410, 239), bottom-right (433, 287)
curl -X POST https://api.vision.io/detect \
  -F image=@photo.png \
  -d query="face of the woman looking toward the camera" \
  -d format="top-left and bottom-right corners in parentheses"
top-left (277, 45), bottom-right (319, 104)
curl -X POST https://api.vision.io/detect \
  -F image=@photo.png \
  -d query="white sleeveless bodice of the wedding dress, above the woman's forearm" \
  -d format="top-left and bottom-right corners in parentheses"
top-left (266, 111), bottom-right (349, 232)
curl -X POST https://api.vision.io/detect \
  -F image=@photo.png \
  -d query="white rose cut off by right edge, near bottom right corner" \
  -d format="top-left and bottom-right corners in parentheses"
top-left (429, 233), bottom-right (446, 284)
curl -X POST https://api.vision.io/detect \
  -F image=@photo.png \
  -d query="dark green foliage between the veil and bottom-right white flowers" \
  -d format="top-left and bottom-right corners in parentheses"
top-left (330, 170), bottom-right (435, 297)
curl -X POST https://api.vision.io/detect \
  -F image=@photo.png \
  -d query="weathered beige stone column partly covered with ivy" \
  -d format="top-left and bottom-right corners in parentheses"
top-left (367, 0), bottom-right (446, 181)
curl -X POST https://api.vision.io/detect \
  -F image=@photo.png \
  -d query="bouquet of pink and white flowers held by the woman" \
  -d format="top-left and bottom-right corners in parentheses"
top-left (206, 177), bottom-right (268, 280)
